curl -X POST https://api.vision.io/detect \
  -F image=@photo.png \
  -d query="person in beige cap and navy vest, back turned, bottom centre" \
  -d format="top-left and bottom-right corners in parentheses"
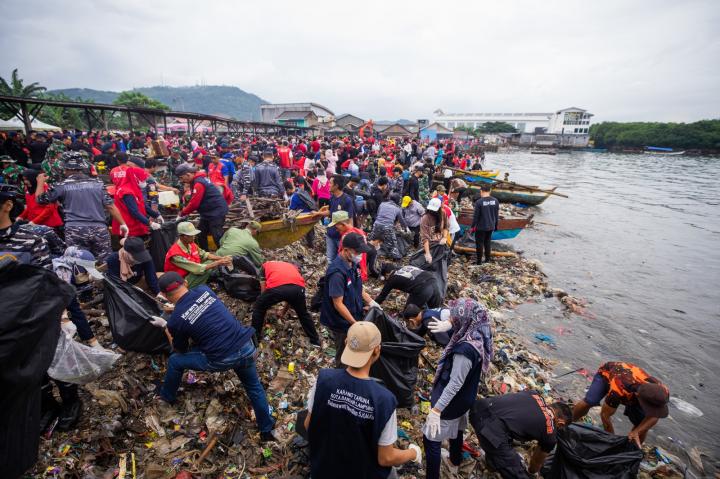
top-left (298, 321), bottom-right (422, 479)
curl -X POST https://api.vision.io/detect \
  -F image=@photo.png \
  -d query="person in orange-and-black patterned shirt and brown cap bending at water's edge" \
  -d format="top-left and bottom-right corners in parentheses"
top-left (573, 362), bottom-right (670, 447)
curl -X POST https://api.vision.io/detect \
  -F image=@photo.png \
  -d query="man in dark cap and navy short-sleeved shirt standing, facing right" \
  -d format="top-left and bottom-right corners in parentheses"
top-left (320, 233), bottom-right (380, 367)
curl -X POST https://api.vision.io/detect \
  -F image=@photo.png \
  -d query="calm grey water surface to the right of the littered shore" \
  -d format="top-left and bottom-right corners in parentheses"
top-left (487, 152), bottom-right (720, 464)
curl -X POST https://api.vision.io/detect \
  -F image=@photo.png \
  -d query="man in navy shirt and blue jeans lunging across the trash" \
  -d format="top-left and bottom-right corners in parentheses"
top-left (151, 272), bottom-right (275, 441)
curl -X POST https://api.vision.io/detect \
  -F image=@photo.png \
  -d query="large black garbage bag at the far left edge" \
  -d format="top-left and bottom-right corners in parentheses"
top-left (0, 259), bottom-right (75, 479)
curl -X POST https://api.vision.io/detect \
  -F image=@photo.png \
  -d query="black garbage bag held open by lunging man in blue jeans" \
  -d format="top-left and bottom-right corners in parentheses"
top-left (103, 275), bottom-right (170, 354)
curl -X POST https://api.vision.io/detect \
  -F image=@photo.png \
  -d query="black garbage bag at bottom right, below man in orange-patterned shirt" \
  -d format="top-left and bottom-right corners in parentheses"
top-left (543, 423), bottom-right (643, 479)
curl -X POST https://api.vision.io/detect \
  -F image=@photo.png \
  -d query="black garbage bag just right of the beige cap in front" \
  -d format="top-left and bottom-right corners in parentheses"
top-left (365, 308), bottom-right (425, 408)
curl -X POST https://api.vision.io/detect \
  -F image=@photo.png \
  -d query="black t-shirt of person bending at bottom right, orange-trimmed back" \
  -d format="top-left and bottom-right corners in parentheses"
top-left (485, 391), bottom-right (557, 452)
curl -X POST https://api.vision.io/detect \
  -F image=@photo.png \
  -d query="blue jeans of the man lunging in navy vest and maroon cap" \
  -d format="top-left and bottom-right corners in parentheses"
top-left (160, 341), bottom-right (275, 432)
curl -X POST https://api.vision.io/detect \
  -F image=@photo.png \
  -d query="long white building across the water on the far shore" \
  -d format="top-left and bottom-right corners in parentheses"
top-left (433, 108), bottom-right (593, 135)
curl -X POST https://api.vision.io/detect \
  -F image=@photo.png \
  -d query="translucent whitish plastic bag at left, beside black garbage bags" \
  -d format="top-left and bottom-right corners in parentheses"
top-left (48, 334), bottom-right (120, 384)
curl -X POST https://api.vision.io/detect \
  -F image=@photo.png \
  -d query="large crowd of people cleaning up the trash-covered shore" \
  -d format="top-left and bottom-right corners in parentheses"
top-left (0, 128), bottom-right (669, 479)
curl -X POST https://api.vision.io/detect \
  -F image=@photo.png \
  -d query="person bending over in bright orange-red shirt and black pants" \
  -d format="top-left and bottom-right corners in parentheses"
top-left (252, 261), bottom-right (320, 346)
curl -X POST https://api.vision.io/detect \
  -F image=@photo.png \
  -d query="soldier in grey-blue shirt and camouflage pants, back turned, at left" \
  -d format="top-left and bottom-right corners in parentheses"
top-left (35, 151), bottom-right (129, 262)
